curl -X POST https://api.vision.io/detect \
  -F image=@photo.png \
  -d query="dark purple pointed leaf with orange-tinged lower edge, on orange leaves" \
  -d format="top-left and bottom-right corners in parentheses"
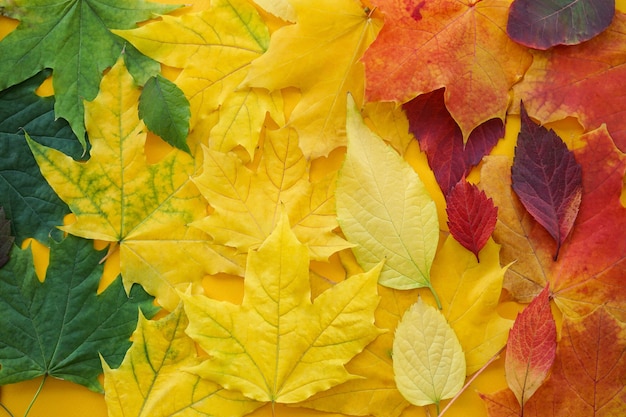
top-left (511, 103), bottom-right (582, 261)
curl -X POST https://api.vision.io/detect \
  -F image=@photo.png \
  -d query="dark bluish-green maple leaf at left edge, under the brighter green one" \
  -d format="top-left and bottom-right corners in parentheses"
top-left (0, 71), bottom-right (78, 245)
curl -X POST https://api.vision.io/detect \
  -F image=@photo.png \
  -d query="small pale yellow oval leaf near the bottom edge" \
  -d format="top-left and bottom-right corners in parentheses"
top-left (393, 298), bottom-right (465, 406)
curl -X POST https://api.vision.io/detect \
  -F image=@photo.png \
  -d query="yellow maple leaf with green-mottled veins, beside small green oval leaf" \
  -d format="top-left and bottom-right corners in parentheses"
top-left (28, 59), bottom-right (242, 310)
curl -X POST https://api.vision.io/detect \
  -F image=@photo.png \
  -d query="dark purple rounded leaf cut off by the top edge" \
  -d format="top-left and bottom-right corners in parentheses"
top-left (506, 0), bottom-right (615, 49)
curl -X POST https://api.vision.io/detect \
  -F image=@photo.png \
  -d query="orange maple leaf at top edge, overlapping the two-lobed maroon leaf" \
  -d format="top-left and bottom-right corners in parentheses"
top-left (363, 0), bottom-right (531, 140)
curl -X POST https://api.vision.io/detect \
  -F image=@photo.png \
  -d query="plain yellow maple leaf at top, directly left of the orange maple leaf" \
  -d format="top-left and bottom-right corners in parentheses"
top-left (245, 0), bottom-right (381, 159)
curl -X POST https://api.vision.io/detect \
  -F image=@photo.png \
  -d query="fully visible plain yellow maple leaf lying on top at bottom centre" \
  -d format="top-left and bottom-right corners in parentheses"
top-left (182, 211), bottom-right (381, 403)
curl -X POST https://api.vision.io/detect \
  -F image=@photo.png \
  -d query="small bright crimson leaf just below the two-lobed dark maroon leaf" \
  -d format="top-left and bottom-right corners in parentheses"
top-left (446, 178), bottom-right (498, 262)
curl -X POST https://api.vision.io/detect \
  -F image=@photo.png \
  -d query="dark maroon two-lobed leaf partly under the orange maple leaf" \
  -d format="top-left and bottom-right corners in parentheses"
top-left (403, 88), bottom-right (504, 195)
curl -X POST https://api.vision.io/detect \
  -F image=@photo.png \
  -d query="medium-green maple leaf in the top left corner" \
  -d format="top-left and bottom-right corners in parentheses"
top-left (0, 0), bottom-right (178, 146)
